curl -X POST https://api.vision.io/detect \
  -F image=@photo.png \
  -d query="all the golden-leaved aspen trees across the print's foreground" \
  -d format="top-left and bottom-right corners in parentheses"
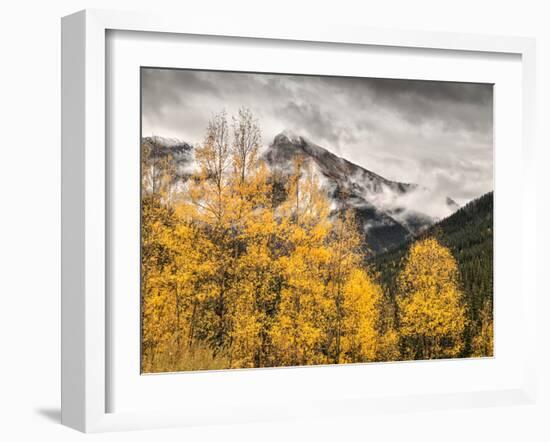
top-left (142, 109), bottom-right (492, 372)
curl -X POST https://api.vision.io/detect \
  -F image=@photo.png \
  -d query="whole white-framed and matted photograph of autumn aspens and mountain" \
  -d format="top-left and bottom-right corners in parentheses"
top-left (62, 11), bottom-right (536, 432)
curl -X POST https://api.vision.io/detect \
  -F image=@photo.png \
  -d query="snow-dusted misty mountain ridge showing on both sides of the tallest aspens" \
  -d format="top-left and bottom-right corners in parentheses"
top-left (143, 131), bottom-right (458, 254)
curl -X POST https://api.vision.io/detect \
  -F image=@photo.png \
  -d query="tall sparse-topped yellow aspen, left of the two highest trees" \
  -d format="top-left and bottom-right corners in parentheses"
top-left (187, 112), bottom-right (237, 352)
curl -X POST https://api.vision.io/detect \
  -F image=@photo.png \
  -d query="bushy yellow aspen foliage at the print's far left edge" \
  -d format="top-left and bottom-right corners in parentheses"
top-left (142, 196), bottom-right (216, 370)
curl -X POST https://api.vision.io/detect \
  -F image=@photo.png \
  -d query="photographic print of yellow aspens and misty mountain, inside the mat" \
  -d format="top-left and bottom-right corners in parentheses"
top-left (140, 67), bottom-right (493, 373)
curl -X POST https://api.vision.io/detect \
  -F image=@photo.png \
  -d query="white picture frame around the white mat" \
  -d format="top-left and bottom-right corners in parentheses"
top-left (62, 10), bottom-right (537, 432)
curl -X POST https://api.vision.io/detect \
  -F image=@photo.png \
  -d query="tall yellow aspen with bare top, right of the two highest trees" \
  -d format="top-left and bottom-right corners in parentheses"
top-left (225, 109), bottom-right (277, 367)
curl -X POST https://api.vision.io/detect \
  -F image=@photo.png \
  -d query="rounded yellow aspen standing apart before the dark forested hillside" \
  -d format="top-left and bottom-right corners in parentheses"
top-left (398, 238), bottom-right (467, 359)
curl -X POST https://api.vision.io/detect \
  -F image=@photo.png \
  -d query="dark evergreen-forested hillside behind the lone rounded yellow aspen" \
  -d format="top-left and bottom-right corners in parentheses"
top-left (376, 192), bottom-right (493, 354)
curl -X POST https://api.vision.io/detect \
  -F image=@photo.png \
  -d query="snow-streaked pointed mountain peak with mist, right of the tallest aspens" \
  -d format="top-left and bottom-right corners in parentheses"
top-left (264, 132), bottom-right (458, 254)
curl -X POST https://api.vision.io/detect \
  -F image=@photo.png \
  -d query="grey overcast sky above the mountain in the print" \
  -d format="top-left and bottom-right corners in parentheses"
top-left (142, 68), bottom-right (493, 204)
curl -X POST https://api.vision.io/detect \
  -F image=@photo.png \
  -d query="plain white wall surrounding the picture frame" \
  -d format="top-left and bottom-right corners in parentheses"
top-left (0, 0), bottom-right (550, 441)
